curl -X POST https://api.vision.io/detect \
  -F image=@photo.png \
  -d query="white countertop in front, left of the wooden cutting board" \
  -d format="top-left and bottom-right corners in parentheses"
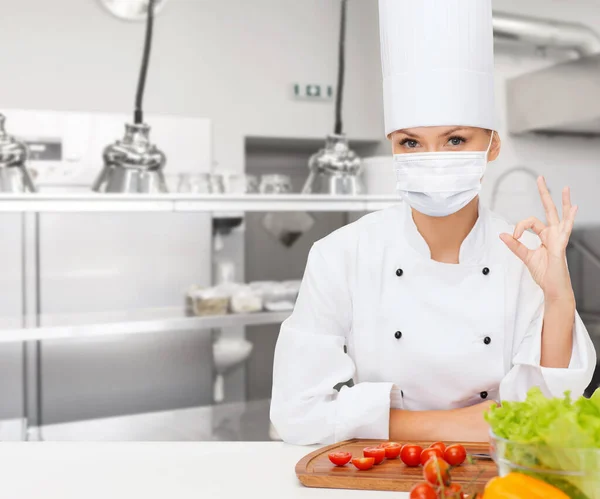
top-left (0, 442), bottom-right (408, 499)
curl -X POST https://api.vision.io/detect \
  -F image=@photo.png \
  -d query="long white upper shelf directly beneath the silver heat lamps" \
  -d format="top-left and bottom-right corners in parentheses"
top-left (0, 193), bottom-right (399, 213)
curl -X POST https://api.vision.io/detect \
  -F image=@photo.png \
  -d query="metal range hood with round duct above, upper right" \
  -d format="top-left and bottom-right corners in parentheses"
top-left (494, 13), bottom-right (600, 136)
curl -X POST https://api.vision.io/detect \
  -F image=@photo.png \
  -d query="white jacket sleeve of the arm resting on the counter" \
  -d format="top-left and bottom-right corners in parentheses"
top-left (271, 243), bottom-right (401, 445)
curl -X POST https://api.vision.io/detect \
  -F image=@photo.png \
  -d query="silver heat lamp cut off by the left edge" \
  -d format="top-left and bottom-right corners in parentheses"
top-left (0, 114), bottom-right (36, 194)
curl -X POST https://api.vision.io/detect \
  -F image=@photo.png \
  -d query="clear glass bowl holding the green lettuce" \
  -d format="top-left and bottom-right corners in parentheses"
top-left (490, 433), bottom-right (600, 499)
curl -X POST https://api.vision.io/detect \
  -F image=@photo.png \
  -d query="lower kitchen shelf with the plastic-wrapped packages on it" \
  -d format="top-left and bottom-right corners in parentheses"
top-left (0, 308), bottom-right (291, 344)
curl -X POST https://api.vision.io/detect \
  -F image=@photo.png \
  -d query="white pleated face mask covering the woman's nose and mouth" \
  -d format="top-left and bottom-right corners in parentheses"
top-left (394, 132), bottom-right (494, 217)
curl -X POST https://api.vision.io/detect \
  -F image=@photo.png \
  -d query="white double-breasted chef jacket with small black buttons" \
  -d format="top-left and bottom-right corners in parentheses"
top-left (271, 203), bottom-right (596, 445)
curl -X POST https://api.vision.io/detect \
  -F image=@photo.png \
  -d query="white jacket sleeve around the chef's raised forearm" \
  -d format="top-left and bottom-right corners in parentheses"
top-left (500, 250), bottom-right (596, 401)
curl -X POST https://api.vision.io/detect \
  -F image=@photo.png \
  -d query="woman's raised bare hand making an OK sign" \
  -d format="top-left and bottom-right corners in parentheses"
top-left (500, 177), bottom-right (577, 303)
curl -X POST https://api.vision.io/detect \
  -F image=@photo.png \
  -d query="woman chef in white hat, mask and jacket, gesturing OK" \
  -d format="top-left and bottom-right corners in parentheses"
top-left (271, 0), bottom-right (596, 444)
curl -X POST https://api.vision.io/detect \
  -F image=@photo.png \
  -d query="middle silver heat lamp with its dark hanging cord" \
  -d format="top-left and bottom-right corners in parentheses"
top-left (92, 0), bottom-right (167, 193)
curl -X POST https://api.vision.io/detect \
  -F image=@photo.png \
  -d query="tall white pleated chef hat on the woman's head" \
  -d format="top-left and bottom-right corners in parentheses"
top-left (379, 0), bottom-right (495, 135)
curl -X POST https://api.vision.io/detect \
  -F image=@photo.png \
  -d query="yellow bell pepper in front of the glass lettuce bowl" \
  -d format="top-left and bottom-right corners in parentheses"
top-left (483, 473), bottom-right (569, 499)
